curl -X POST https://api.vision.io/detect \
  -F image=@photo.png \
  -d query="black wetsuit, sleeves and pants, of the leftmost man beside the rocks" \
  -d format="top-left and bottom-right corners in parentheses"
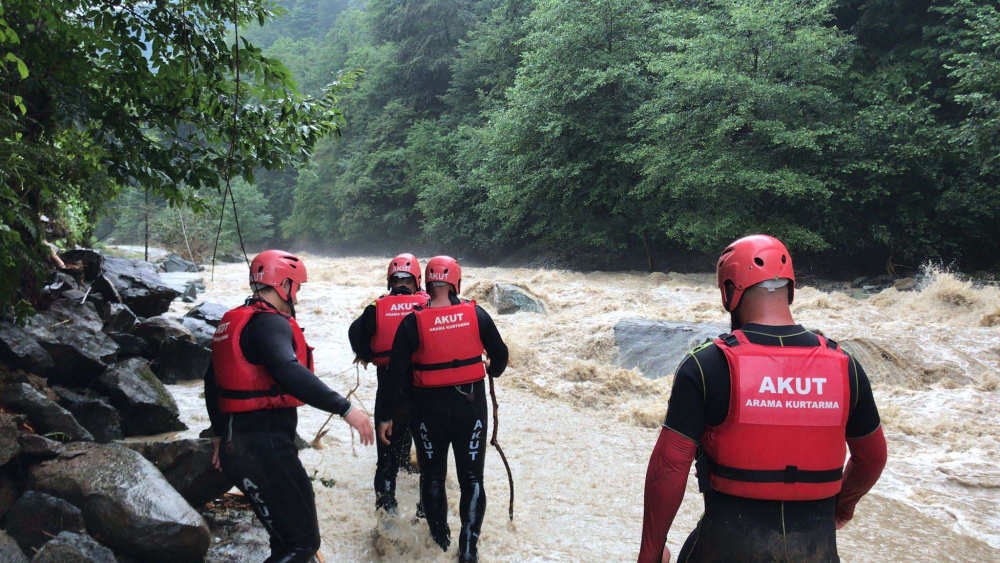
top-left (205, 302), bottom-right (351, 563)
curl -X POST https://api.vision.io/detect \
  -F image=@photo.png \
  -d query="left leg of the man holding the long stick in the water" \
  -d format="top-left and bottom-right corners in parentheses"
top-left (410, 388), bottom-right (454, 551)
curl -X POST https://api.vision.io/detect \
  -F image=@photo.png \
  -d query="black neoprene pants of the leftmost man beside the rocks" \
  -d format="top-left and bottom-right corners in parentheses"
top-left (219, 409), bottom-right (320, 563)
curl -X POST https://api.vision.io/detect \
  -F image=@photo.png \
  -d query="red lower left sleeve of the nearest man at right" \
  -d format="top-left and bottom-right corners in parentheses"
top-left (639, 428), bottom-right (698, 563)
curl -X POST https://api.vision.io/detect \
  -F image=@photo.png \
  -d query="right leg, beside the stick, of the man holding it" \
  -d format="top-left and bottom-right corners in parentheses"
top-left (451, 381), bottom-right (489, 563)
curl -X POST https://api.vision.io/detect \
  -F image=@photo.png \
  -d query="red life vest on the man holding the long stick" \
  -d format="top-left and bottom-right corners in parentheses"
top-left (411, 301), bottom-right (486, 387)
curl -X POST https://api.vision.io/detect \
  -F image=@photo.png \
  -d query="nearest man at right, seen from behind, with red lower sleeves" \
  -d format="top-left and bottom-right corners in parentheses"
top-left (638, 235), bottom-right (886, 563)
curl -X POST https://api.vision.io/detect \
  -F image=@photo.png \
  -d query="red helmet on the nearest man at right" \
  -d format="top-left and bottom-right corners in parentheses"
top-left (716, 235), bottom-right (795, 311)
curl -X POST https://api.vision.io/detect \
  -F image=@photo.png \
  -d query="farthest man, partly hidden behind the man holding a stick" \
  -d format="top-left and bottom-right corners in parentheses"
top-left (347, 254), bottom-right (429, 514)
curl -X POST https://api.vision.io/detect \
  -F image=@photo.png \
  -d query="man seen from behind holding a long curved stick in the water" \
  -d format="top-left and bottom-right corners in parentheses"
top-left (379, 256), bottom-right (507, 563)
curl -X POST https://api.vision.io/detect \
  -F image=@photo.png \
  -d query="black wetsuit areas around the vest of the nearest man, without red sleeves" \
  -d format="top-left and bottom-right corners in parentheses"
top-left (664, 324), bottom-right (880, 563)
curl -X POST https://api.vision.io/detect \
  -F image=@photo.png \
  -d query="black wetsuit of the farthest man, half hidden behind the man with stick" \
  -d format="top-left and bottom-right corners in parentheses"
top-left (347, 287), bottom-right (413, 512)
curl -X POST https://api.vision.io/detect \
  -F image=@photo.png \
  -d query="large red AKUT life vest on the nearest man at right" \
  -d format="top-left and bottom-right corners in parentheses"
top-left (698, 330), bottom-right (851, 500)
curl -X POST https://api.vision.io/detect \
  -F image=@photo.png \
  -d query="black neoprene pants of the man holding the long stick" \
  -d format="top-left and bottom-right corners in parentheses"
top-left (410, 381), bottom-right (489, 557)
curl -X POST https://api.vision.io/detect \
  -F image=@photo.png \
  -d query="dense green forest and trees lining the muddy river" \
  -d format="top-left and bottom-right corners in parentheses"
top-left (0, 0), bottom-right (1000, 306)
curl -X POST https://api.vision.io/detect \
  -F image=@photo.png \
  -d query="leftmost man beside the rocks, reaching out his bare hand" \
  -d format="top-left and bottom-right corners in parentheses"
top-left (205, 250), bottom-right (374, 563)
